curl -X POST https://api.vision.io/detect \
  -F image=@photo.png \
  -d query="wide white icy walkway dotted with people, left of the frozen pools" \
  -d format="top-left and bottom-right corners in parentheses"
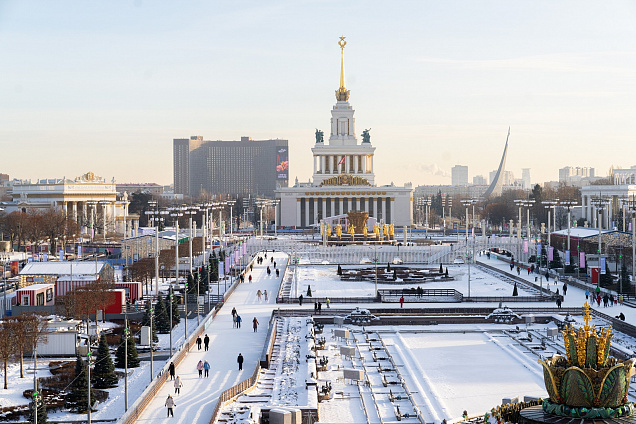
top-left (137, 252), bottom-right (287, 424)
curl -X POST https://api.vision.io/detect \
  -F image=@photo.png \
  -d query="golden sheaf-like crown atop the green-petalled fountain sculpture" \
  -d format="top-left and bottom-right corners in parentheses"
top-left (562, 302), bottom-right (613, 369)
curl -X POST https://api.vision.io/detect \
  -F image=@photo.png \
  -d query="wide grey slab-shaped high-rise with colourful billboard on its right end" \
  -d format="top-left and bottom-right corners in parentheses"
top-left (173, 136), bottom-right (289, 197)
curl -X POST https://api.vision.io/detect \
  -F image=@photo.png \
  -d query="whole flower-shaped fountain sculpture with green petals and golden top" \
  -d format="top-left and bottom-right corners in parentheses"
top-left (539, 302), bottom-right (636, 418)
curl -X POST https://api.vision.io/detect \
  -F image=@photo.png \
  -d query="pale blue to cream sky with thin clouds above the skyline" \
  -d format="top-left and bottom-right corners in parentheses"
top-left (0, 0), bottom-right (636, 186)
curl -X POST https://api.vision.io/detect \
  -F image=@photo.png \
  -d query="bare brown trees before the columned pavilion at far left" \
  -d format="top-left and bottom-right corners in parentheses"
top-left (0, 209), bottom-right (80, 252)
